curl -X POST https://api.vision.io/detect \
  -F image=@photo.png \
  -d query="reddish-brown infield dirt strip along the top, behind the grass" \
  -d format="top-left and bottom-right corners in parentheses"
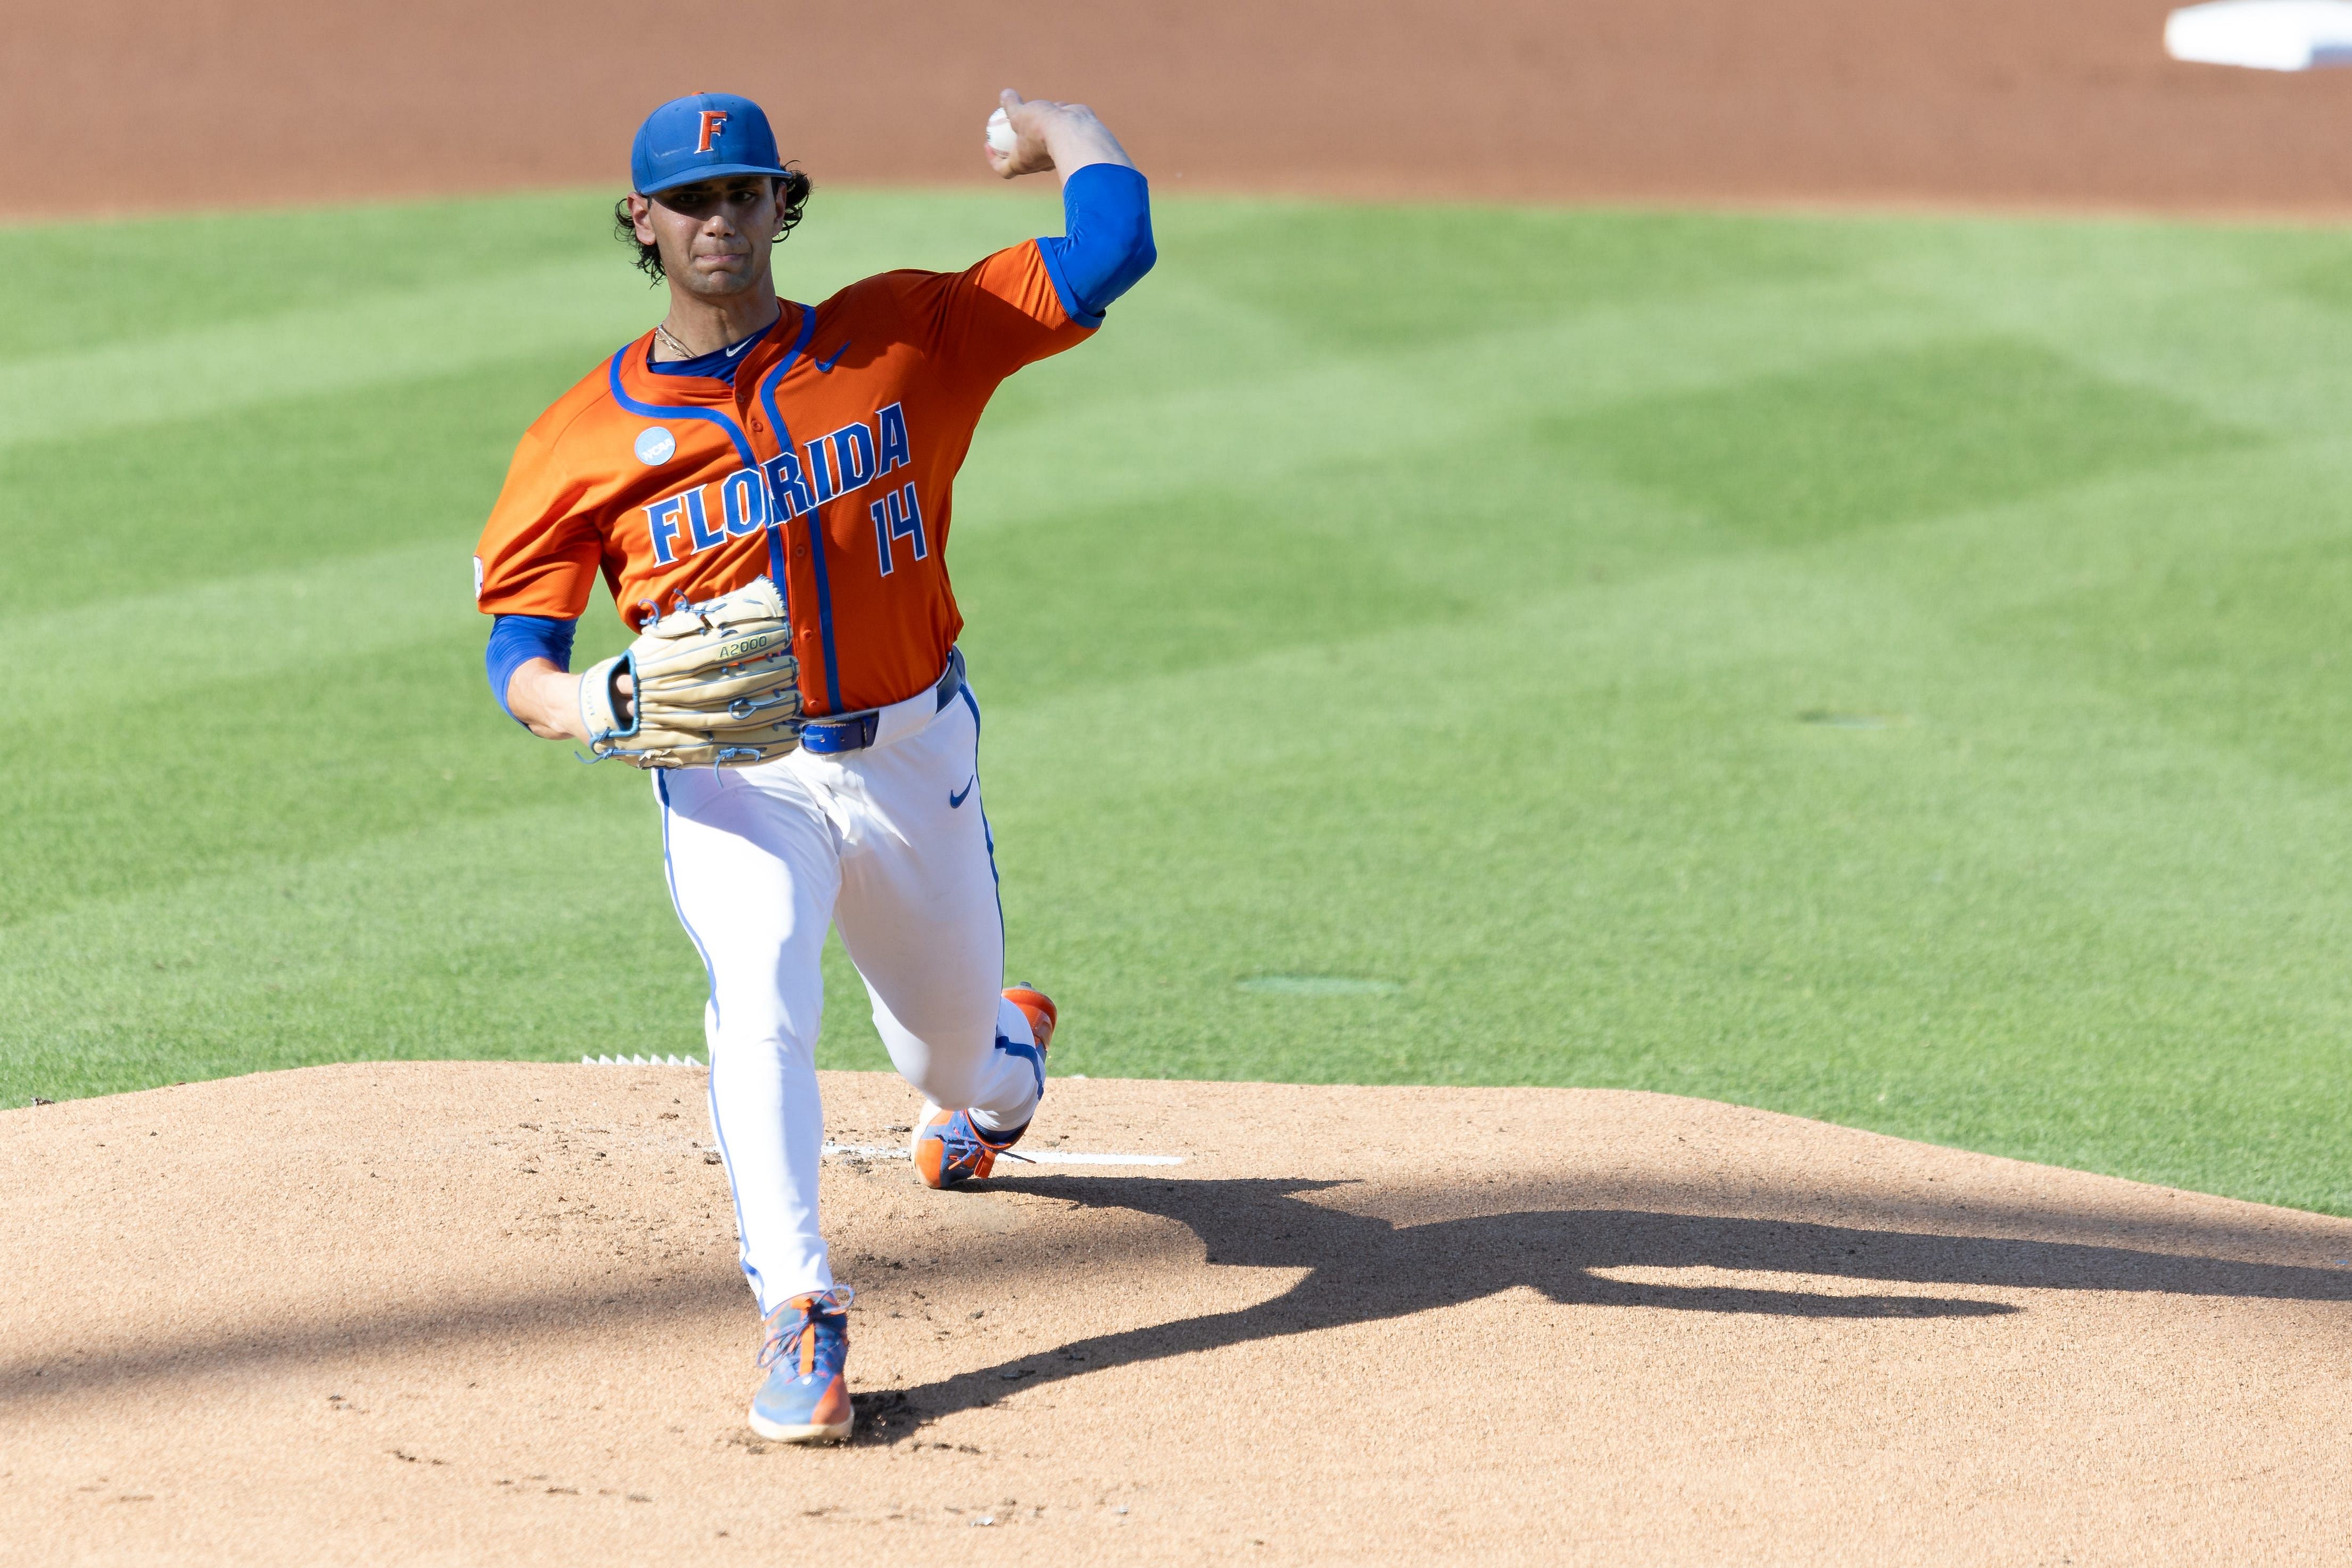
top-left (13, 0), bottom-right (2352, 214)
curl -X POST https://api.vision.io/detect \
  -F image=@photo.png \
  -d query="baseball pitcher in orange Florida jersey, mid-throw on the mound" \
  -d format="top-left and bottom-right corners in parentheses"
top-left (473, 92), bottom-right (1155, 1441)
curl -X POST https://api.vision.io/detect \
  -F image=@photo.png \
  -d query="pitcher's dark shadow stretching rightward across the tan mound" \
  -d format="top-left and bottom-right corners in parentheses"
top-left (858, 1175), bottom-right (2352, 1443)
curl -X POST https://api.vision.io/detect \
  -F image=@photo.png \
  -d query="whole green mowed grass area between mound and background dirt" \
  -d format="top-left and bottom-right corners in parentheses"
top-left (0, 188), bottom-right (2352, 1213)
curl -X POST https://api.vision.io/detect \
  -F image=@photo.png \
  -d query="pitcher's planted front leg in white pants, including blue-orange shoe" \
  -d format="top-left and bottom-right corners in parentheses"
top-left (654, 764), bottom-right (849, 1437)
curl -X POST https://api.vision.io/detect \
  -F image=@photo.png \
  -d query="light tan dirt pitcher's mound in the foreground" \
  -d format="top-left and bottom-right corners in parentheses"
top-left (0, 1065), bottom-right (2352, 1566)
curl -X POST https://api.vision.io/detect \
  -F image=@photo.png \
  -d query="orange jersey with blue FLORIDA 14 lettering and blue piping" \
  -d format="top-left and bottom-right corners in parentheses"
top-left (475, 242), bottom-right (1091, 715)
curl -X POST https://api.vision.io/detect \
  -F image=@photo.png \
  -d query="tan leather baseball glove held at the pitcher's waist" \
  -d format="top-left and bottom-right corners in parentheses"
top-left (581, 578), bottom-right (800, 769)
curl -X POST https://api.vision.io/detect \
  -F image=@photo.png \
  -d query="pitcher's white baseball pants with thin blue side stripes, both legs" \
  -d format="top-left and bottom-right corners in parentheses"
top-left (654, 691), bottom-right (1044, 1314)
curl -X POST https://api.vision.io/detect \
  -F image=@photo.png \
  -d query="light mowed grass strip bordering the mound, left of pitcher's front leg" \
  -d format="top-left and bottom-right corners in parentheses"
top-left (0, 799), bottom-right (701, 1081)
